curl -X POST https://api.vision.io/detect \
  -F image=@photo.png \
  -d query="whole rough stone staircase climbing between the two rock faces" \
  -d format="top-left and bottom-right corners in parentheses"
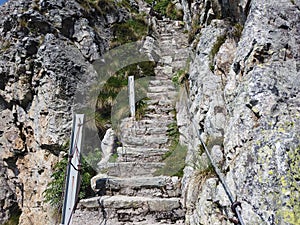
top-left (72, 20), bottom-right (189, 225)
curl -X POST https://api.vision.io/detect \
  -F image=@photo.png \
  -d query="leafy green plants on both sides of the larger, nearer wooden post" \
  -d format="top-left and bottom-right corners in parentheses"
top-left (44, 145), bottom-right (96, 211)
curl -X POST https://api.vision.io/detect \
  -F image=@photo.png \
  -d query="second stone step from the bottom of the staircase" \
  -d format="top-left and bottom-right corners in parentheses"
top-left (92, 174), bottom-right (181, 198)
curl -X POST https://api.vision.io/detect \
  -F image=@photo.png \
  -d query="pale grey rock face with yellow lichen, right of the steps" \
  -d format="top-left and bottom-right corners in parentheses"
top-left (179, 0), bottom-right (300, 225)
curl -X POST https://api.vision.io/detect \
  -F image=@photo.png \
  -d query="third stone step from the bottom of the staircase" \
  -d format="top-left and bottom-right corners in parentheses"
top-left (107, 162), bottom-right (164, 177)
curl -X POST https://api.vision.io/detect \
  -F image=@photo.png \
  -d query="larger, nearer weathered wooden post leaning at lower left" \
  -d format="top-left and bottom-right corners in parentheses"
top-left (61, 114), bottom-right (84, 225)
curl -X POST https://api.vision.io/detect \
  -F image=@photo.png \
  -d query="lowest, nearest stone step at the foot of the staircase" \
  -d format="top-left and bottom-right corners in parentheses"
top-left (73, 195), bottom-right (184, 225)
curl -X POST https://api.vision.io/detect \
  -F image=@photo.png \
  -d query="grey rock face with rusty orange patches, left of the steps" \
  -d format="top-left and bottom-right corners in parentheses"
top-left (0, 0), bottom-right (128, 225)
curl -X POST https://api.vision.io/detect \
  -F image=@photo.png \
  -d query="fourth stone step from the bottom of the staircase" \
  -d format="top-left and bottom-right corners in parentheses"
top-left (117, 147), bottom-right (169, 162)
